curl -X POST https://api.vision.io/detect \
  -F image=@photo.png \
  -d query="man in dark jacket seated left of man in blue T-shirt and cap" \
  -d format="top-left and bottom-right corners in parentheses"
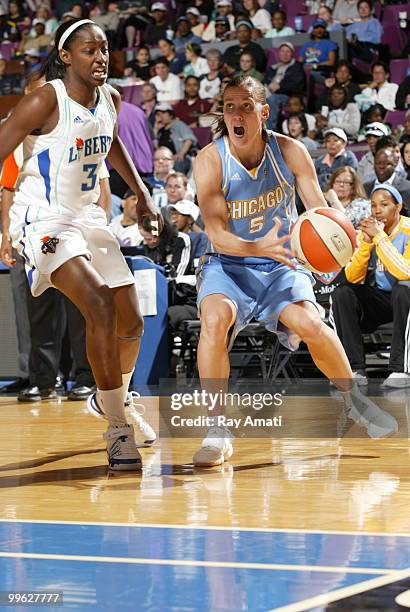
top-left (264, 42), bottom-right (306, 130)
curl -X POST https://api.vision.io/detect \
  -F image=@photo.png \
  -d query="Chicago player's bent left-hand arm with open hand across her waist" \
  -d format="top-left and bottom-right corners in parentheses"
top-left (194, 144), bottom-right (294, 268)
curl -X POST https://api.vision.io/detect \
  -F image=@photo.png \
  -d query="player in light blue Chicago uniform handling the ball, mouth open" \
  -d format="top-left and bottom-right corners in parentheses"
top-left (194, 76), bottom-right (397, 466)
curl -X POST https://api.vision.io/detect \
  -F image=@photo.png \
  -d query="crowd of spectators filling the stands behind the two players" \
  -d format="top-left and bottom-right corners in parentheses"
top-left (0, 0), bottom-right (410, 392)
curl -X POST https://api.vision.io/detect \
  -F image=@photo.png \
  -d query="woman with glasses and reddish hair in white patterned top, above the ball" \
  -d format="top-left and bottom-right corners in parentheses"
top-left (324, 166), bottom-right (371, 229)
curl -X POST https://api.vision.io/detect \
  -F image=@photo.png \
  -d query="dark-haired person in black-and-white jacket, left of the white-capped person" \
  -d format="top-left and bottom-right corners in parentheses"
top-left (139, 218), bottom-right (192, 278)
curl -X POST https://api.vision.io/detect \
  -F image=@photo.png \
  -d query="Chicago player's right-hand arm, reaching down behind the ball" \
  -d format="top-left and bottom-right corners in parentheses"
top-left (276, 134), bottom-right (327, 210)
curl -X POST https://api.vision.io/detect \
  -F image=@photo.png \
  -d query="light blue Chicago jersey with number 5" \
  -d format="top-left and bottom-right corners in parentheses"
top-left (215, 132), bottom-right (298, 264)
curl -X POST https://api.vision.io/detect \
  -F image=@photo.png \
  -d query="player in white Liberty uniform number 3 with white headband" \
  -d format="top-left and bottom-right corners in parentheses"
top-left (0, 19), bottom-right (162, 470)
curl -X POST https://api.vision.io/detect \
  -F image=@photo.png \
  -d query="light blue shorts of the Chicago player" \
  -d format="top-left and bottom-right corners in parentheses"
top-left (197, 255), bottom-right (316, 350)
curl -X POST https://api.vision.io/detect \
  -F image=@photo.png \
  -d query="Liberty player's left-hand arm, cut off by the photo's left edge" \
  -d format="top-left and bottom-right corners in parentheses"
top-left (0, 84), bottom-right (58, 163)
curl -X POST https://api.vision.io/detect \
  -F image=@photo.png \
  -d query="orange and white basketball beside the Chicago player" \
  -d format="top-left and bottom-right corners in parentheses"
top-left (290, 208), bottom-right (356, 273)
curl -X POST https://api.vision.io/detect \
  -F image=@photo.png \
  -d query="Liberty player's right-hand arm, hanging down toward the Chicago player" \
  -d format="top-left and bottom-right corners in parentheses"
top-left (107, 88), bottom-right (164, 231)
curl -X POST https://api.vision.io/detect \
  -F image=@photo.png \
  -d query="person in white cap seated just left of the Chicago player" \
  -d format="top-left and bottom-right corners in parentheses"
top-left (168, 200), bottom-right (208, 260)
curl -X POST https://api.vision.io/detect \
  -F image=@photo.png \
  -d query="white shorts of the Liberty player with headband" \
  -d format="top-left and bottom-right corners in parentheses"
top-left (10, 204), bottom-right (135, 297)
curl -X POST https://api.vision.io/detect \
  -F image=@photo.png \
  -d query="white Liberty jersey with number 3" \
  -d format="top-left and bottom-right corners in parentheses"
top-left (14, 79), bottom-right (117, 222)
